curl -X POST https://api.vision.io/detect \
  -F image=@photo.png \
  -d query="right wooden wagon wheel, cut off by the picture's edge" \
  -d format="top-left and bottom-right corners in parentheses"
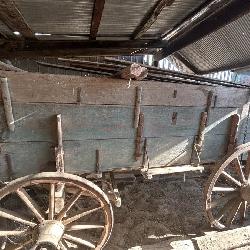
top-left (205, 143), bottom-right (250, 229)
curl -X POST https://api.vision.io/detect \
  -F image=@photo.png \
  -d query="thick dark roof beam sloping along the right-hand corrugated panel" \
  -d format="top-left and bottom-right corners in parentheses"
top-left (155, 0), bottom-right (250, 60)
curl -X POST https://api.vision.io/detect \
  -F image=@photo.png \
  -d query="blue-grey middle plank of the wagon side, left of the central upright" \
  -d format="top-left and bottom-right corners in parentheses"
top-left (0, 104), bottom-right (135, 142)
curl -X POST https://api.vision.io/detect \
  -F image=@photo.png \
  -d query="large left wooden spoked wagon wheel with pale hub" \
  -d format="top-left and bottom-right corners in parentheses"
top-left (0, 172), bottom-right (113, 250)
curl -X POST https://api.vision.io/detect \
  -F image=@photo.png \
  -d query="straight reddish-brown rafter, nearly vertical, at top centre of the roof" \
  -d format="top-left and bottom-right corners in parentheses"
top-left (89, 0), bottom-right (105, 40)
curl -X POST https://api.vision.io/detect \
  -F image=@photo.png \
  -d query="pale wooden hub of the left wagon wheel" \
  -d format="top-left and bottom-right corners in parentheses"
top-left (34, 220), bottom-right (64, 250)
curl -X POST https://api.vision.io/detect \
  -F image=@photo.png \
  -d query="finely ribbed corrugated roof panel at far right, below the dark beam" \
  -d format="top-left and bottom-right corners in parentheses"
top-left (180, 13), bottom-right (250, 72)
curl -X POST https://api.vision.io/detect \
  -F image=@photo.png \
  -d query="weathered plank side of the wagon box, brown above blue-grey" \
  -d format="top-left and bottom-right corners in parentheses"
top-left (0, 71), bottom-right (249, 178)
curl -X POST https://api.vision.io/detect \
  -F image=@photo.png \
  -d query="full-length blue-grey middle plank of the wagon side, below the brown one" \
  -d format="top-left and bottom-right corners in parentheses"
top-left (0, 104), bottom-right (242, 142)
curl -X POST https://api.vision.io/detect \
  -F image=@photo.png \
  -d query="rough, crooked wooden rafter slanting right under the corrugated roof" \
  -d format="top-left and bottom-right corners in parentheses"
top-left (132, 0), bottom-right (174, 39)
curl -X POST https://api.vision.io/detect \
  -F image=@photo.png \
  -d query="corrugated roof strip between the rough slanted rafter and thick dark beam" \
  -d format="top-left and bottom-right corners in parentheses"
top-left (145, 0), bottom-right (206, 37)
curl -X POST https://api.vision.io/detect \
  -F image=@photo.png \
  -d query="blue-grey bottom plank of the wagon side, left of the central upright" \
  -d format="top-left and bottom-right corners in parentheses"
top-left (0, 139), bottom-right (141, 178)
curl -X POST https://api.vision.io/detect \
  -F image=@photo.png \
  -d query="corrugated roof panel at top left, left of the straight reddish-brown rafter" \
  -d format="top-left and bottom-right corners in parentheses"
top-left (15, 0), bottom-right (93, 34)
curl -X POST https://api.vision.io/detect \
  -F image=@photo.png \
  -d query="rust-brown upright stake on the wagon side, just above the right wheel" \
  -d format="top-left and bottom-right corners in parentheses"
top-left (227, 114), bottom-right (240, 153)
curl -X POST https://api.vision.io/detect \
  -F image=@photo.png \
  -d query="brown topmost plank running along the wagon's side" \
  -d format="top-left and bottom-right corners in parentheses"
top-left (0, 71), bottom-right (249, 107)
